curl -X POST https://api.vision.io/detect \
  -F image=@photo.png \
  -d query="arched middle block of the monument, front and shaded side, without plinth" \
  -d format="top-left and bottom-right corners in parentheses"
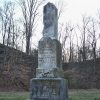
top-left (38, 37), bottom-right (62, 68)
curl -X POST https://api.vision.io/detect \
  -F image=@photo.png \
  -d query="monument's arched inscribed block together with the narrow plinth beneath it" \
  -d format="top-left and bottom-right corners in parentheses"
top-left (36, 37), bottom-right (62, 77)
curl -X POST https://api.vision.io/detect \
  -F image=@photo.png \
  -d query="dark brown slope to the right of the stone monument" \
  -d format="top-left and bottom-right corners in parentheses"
top-left (63, 58), bottom-right (100, 89)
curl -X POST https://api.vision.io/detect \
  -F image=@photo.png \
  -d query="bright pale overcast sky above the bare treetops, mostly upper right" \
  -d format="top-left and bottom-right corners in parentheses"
top-left (0, 0), bottom-right (100, 23)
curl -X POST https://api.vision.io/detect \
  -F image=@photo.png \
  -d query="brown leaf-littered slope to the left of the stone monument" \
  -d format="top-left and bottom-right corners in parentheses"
top-left (0, 44), bottom-right (37, 91)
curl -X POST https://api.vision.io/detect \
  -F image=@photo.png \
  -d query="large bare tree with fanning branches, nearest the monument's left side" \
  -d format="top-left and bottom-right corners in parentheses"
top-left (20, 0), bottom-right (44, 54)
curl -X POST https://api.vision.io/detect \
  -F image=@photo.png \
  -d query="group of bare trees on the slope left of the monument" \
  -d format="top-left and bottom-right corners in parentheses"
top-left (0, 0), bottom-right (44, 54)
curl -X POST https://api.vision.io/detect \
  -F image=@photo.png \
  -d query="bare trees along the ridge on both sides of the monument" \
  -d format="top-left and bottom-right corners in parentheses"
top-left (0, 0), bottom-right (100, 62)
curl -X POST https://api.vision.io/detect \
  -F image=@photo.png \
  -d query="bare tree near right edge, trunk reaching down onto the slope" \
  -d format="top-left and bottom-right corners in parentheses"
top-left (87, 18), bottom-right (98, 75)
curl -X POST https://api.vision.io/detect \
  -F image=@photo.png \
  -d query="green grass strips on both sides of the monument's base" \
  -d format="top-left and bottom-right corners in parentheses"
top-left (0, 89), bottom-right (100, 100)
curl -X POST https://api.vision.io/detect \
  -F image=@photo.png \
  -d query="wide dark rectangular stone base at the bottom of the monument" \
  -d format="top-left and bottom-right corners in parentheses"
top-left (30, 78), bottom-right (68, 100)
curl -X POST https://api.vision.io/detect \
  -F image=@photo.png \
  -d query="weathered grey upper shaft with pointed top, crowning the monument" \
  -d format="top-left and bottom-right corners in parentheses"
top-left (43, 3), bottom-right (58, 39)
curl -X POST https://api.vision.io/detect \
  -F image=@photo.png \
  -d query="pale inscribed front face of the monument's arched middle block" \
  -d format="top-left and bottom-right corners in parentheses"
top-left (38, 38), bottom-right (57, 68)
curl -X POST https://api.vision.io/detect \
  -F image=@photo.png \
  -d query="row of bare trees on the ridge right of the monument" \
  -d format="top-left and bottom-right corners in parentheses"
top-left (60, 13), bottom-right (100, 62)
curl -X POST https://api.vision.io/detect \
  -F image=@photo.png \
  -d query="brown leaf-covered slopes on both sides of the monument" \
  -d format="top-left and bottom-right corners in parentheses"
top-left (0, 44), bottom-right (100, 91)
